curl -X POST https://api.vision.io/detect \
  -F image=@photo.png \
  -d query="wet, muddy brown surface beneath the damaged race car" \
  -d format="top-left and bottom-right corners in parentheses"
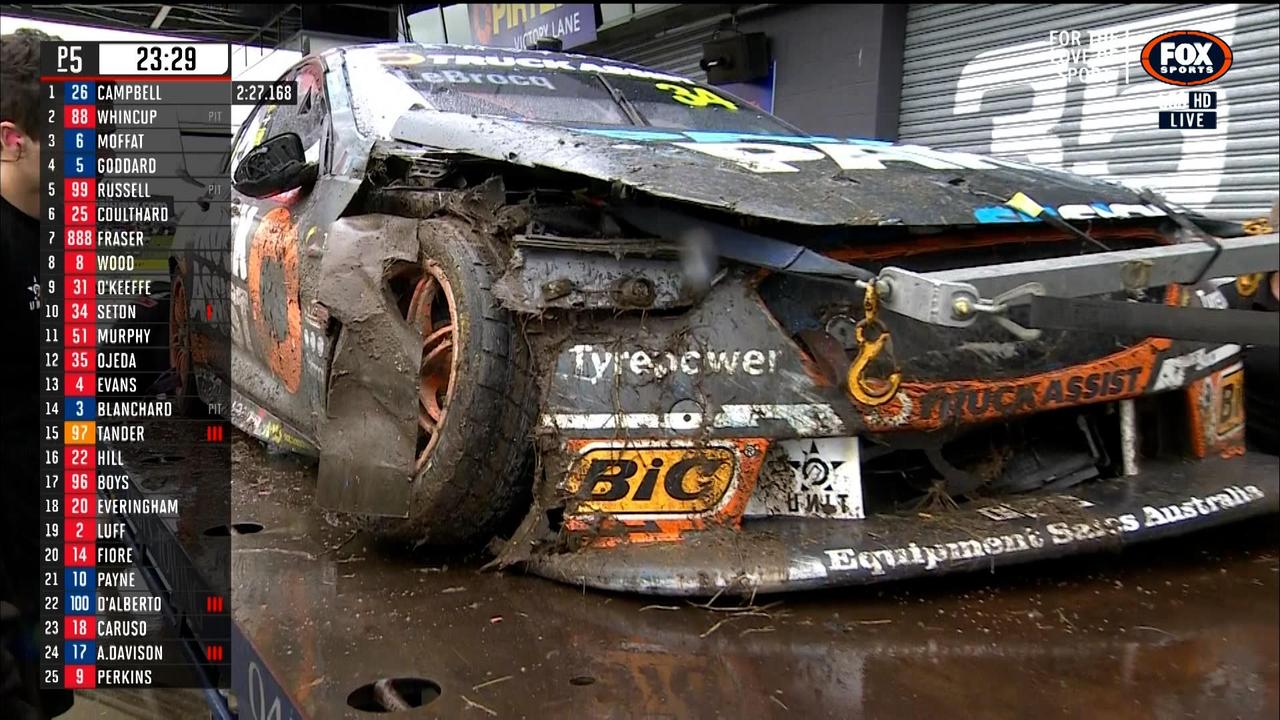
top-left (78, 439), bottom-right (1280, 720)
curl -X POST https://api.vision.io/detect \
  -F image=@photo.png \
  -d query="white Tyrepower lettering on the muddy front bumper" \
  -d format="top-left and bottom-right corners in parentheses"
top-left (568, 345), bottom-right (780, 384)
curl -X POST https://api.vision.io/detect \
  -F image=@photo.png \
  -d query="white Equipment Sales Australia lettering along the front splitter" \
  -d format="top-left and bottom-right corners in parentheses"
top-left (823, 486), bottom-right (1266, 575)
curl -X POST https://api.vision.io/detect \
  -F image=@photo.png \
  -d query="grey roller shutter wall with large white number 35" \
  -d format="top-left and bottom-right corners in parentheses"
top-left (899, 4), bottom-right (1280, 219)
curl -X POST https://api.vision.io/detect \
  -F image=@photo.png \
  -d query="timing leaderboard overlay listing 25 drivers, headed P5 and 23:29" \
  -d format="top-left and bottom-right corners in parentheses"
top-left (38, 42), bottom-right (232, 689)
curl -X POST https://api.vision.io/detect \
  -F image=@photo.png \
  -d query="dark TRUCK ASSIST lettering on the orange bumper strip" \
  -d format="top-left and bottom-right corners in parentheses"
top-left (920, 368), bottom-right (1143, 421)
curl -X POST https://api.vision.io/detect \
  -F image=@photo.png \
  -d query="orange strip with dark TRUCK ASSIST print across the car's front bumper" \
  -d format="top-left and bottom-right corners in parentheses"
top-left (860, 338), bottom-right (1172, 430)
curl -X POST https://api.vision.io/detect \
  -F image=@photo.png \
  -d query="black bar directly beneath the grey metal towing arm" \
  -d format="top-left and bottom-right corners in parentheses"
top-left (1025, 296), bottom-right (1280, 347)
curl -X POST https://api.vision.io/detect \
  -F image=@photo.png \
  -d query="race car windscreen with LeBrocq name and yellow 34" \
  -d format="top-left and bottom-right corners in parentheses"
top-left (347, 46), bottom-right (796, 135)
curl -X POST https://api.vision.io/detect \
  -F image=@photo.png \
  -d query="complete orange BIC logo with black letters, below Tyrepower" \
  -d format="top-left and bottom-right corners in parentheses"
top-left (566, 441), bottom-right (737, 519)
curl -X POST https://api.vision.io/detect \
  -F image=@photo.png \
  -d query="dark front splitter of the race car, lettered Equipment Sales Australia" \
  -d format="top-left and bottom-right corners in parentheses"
top-left (529, 454), bottom-right (1280, 597)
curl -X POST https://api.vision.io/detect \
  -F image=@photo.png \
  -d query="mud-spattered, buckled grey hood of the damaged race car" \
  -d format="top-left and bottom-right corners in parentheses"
top-left (392, 111), bottom-right (1164, 225)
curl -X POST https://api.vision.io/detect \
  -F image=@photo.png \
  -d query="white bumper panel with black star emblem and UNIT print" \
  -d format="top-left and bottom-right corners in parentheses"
top-left (746, 437), bottom-right (865, 520)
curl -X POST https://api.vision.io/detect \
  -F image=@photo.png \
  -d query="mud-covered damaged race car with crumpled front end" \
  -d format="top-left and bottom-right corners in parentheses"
top-left (170, 44), bottom-right (1277, 594)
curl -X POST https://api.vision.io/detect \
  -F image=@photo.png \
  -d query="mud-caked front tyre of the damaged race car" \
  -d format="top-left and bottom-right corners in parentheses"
top-left (367, 218), bottom-right (538, 546)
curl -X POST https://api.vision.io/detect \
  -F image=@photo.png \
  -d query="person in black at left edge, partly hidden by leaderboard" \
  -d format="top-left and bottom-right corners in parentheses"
top-left (0, 29), bottom-right (72, 720)
